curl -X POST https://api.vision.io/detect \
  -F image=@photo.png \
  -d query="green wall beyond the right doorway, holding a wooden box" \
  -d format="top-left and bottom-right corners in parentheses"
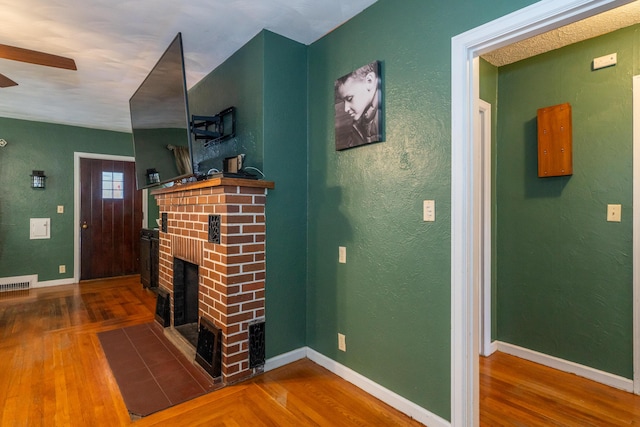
top-left (496, 27), bottom-right (638, 378)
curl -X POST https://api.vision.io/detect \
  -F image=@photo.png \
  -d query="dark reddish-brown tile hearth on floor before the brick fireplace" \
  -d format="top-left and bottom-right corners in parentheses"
top-left (98, 322), bottom-right (216, 416)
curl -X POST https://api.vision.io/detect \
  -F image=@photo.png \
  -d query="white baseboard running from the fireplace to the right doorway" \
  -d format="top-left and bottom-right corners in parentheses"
top-left (265, 347), bottom-right (451, 427)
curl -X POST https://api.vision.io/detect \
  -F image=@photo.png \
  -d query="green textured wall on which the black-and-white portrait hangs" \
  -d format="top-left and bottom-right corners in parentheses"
top-left (307, 0), bottom-right (532, 418)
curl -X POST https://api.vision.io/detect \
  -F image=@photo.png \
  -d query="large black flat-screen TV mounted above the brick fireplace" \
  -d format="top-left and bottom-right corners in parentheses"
top-left (129, 33), bottom-right (193, 189)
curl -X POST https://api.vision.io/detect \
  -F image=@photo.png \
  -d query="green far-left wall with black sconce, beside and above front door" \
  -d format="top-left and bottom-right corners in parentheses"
top-left (0, 118), bottom-right (133, 282)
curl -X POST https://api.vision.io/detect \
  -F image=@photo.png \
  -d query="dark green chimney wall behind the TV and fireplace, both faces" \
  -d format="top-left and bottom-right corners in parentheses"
top-left (178, 31), bottom-right (307, 357)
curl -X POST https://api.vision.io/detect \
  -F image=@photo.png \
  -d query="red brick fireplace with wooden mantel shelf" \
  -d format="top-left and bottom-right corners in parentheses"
top-left (152, 178), bottom-right (274, 384)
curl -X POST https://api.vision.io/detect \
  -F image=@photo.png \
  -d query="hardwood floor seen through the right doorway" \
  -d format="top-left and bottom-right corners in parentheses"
top-left (480, 352), bottom-right (640, 427)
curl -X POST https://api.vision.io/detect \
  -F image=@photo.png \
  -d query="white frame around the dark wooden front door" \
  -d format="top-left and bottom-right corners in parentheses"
top-left (73, 151), bottom-right (147, 283)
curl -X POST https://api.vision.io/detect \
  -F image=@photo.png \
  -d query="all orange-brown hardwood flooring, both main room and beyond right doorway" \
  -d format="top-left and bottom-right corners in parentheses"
top-left (5, 276), bottom-right (640, 427)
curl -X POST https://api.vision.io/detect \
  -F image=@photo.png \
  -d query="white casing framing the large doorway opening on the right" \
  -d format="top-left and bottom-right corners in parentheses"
top-left (451, 0), bottom-right (631, 427)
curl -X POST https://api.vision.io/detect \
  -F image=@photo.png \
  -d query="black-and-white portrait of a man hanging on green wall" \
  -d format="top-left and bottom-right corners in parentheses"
top-left (334, 61), bottom-right (382, 150)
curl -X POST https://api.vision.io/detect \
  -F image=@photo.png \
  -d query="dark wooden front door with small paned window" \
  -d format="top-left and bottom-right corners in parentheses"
top-left (79, 159), bottom-right (142, 280)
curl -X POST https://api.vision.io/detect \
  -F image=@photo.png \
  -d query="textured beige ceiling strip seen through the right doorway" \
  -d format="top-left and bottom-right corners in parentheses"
top-left (482, 1), bottom-right (640, 67)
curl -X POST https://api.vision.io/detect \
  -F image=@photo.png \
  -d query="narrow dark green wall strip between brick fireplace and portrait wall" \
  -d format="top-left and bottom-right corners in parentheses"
top-left (264, 31), bottom-right (307, 357)
